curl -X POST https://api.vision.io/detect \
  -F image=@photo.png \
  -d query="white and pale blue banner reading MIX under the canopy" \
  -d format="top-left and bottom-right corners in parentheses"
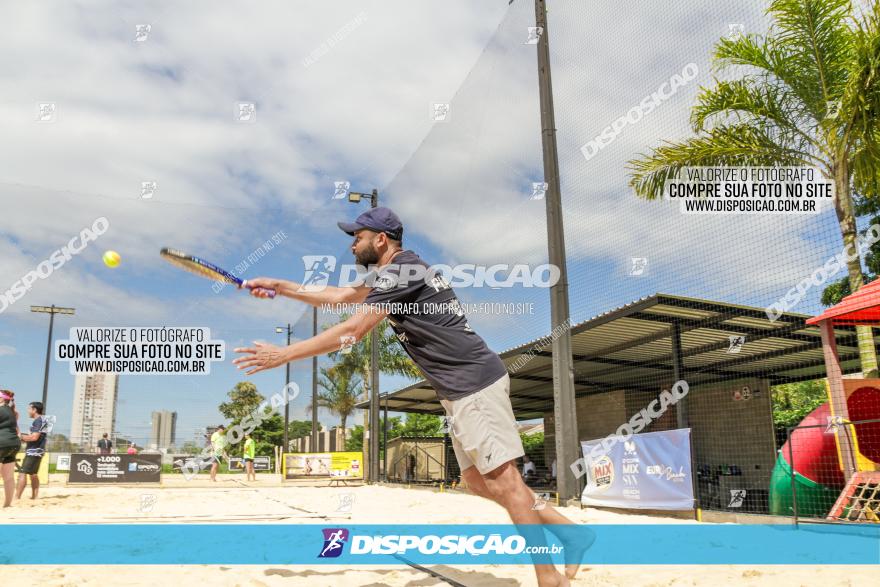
top-left (581, 428), bottom-right (694, 510)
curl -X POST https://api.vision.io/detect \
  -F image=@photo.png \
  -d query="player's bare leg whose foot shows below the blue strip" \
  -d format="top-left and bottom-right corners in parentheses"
top-left (474, 461), bottom-right (569, 587)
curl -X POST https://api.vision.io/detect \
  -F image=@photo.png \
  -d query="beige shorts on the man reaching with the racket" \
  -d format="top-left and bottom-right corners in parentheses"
top-left (440, 373), bottom-right (525, 475)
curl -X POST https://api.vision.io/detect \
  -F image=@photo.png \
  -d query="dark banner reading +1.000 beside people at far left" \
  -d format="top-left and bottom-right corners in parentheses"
top-left (67, 454), bottom-right (162, 483)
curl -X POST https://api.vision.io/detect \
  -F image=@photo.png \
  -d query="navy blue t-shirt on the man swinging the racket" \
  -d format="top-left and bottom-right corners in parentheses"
top-left (365, 251), bottom-right (507, 400)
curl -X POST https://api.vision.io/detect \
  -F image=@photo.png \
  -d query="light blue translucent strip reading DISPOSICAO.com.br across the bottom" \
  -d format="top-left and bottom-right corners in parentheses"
top-left (0, 524), bottom-right (880, 566)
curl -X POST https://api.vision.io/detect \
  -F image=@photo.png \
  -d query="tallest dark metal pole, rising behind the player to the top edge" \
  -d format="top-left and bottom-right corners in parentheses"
top-left (535, 0), bottom-right (580, 500)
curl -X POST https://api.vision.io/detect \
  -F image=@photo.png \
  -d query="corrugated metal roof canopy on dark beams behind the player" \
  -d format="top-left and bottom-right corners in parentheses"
top-left (356, 294), bottom-right (860, 420)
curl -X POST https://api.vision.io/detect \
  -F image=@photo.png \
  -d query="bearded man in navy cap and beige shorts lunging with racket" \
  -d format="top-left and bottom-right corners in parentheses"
top-left (233, 208), bottom-right (589, 586)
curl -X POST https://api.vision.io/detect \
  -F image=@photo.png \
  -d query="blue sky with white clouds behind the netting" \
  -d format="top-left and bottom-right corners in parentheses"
top-left (0, 0), bottom-right (860, 440)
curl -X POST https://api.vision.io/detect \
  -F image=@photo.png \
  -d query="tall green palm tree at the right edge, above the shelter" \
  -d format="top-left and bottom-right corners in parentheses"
top-left (629, 0), bottom-right (880, 375)
